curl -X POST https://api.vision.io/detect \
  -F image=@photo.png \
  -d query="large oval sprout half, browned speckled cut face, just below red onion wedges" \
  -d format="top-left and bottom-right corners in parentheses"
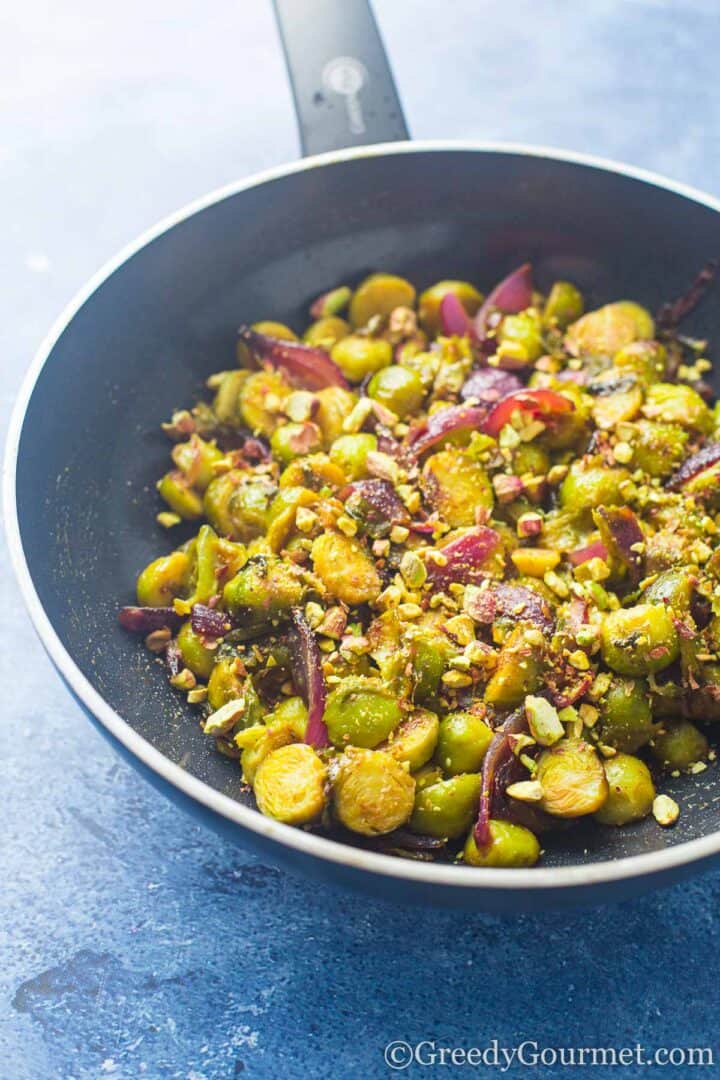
top-left (421, 449), bottom-right (493, 528)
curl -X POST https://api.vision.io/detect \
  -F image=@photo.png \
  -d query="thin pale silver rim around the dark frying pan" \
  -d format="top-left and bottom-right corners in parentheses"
top-left (8, 139), bottom-right (720, 892)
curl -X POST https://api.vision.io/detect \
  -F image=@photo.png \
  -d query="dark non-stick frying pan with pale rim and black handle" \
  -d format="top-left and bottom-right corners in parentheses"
top-left (4, 0), bottom-right (720, 910)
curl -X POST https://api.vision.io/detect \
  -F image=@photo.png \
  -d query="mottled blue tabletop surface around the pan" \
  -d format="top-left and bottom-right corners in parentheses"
top-left (0, 0), bottom-right (720, 1080)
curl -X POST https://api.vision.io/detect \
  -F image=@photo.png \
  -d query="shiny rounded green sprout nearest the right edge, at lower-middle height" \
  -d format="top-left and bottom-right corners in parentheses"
top-left (601, 604), bottom-right (680, 676)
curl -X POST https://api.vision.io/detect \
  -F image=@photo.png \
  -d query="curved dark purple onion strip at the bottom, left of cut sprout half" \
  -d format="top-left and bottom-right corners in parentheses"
top-left (474, 708), bottom-right (553, 848)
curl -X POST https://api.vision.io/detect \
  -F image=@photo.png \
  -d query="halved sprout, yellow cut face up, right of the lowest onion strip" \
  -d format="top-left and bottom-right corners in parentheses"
top-left (535, 739), bottom-right (608, 818)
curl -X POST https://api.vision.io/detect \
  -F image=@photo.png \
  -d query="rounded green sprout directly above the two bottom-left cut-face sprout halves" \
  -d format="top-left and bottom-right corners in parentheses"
top-left (323, 676), bottom-right (403, 750)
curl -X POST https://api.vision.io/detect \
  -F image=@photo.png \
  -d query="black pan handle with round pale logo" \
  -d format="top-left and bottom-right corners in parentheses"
top-left (273, 0), bottom-right (408, 157)
